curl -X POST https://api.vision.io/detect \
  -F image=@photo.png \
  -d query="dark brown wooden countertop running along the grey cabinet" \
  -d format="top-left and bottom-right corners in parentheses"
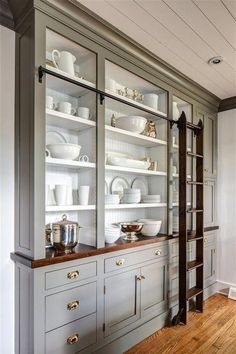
top-left (11, 226), bottom-right (219, 268)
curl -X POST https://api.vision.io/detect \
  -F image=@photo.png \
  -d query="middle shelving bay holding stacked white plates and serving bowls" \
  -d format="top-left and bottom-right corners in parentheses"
top-left (105, 61), bottom-right (167, 243)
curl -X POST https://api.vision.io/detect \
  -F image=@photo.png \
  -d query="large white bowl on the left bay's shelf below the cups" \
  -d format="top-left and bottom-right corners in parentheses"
top-left (47, 143), bottom-right (81, 160)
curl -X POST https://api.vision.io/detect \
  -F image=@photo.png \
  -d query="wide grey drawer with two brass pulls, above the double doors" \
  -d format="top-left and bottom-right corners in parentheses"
top-left (105, 245), bottom-right (168, 273)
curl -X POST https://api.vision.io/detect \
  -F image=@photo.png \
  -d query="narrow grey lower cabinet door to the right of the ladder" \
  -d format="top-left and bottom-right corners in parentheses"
top-left (204, 243), bottom-right (216, 288)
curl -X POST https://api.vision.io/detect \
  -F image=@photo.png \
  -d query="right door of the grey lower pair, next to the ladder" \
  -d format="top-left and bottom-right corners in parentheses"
top-left (141, 261), bottom-right (168, 316)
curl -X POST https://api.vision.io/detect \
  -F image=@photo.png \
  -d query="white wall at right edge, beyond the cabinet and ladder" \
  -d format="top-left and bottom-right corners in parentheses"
top-left (218, 109), bottom-right (236, 286)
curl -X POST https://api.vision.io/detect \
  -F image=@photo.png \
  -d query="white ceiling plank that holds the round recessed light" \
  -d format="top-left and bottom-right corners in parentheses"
top-left (134, 0), bottom-right (236, 90)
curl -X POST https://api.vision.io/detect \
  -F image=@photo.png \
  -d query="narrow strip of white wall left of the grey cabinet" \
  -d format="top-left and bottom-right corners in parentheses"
top-left (0, 26), bottom-right (15, 354)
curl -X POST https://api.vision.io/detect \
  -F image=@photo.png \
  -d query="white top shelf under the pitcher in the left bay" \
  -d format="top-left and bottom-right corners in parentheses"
top-left (46, 65), bottom-right (96, 96)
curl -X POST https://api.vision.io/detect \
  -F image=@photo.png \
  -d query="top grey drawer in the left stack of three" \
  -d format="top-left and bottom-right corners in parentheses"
top-left (45, 262), bottom-right (97, 290)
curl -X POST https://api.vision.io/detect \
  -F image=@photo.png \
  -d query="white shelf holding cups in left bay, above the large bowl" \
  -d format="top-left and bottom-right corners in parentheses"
top-left (46, 109), bottom-right (96, 131)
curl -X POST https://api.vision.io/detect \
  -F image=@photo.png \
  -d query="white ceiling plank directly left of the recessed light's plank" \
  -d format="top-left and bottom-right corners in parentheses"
top-left (107, 0), bottom-right (234, 94)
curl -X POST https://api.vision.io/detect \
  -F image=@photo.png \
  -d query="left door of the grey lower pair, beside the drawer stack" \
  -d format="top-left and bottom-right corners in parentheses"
top-left (105, 269), bottom-right (140, 336)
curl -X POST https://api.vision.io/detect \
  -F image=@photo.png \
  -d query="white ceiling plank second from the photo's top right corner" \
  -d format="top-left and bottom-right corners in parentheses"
top-left (193, 0), bottom-right (236, 50)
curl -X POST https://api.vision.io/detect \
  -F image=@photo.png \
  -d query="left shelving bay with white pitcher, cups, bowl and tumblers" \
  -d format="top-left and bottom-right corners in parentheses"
top-left (45, 29), bottom-right (97, 247)
